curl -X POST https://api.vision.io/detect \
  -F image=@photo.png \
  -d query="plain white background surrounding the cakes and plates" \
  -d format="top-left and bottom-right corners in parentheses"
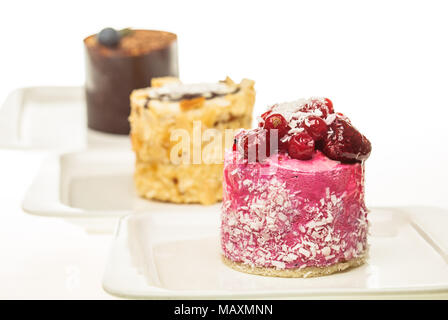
top-left (0, 0), bottom-right (448, 298)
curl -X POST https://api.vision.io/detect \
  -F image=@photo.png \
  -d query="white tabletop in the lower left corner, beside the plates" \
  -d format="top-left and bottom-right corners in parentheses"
top-left (0, 150), bottom-right (112, 299)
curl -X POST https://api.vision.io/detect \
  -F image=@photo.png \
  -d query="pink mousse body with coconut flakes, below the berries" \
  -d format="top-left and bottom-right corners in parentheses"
top-left (221, 152), bottom-right (368, 270)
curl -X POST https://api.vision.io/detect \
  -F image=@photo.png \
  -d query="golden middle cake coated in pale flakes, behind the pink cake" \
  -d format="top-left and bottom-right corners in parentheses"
top-left (129, 77), bottom-right (255, 204)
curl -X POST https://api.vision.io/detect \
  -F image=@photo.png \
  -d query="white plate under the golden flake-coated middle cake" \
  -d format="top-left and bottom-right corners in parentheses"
top-left (22, 148), bottom-right (219, 233)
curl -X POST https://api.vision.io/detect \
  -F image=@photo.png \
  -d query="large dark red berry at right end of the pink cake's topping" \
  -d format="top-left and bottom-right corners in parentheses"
top-left (322, 117), bottom-right (372, 163)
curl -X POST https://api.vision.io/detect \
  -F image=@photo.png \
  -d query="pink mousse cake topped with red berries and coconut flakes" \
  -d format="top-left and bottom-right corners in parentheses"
top-left (221, 98), bottom-right (371, 277)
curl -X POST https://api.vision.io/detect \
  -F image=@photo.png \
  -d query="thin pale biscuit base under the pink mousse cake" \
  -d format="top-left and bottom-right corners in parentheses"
top-left (221, 254), bottom-right (367, 278)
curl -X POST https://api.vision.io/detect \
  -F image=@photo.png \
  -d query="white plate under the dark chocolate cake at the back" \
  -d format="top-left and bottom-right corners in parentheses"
top-left (0, 87), bottom-right (130, 150)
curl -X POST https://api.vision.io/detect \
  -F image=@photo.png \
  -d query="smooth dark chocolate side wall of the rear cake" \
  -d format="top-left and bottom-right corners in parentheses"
top-left (85, 30), bottom-right (178, 134)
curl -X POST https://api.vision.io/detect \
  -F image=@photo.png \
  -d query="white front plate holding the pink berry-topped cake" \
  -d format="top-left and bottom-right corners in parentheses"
top-left (103, 207), bottom-right (448, 298)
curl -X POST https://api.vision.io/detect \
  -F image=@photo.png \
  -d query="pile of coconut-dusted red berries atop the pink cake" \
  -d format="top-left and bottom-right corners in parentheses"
top-left (234, 98), bottom-right (372, 163)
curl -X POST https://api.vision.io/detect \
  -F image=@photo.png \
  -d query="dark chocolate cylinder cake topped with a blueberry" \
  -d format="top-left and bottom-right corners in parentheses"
top-left (84, 28), bottom-right (178, 134)
